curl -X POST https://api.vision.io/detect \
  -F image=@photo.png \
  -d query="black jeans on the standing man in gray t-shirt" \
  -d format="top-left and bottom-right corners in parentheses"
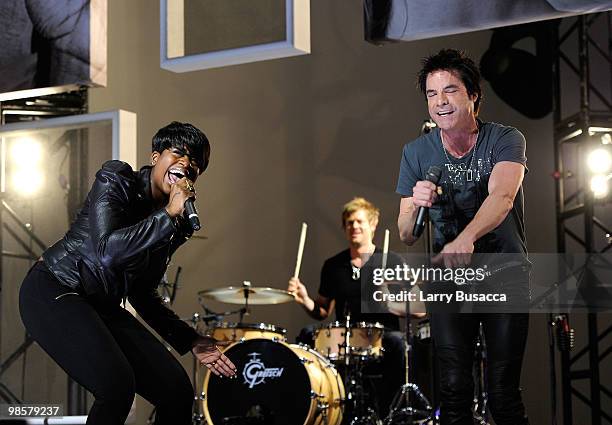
top-left (431, 313), bottom-right (529, 425)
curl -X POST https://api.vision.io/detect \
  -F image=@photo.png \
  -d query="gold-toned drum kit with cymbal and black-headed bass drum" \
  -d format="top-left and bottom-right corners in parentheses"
top-left (191, 282), bottom-right (429, 425)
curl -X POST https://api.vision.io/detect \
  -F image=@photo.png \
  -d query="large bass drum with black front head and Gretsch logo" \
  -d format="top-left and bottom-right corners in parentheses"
top-left (203, 339), bottom-right (344, 425)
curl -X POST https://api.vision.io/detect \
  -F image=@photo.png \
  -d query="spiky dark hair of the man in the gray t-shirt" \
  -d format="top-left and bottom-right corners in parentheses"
top-left (417, 49), bottom-right (482, 115)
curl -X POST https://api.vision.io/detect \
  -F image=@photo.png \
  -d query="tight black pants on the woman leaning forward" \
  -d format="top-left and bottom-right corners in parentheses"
top-left (19, 262), bottom-right (194, 425)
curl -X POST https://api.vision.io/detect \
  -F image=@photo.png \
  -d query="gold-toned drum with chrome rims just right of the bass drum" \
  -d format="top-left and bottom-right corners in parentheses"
top-left (314, 322), bottom-right (384, 361)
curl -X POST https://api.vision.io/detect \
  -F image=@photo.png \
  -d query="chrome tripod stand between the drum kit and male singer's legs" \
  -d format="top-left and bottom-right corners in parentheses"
top-left (384, 301), bottom-right (433, 425)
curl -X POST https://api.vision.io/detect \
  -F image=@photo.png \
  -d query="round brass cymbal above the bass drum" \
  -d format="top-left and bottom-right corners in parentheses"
top-left (198, 286), bottom-right (295, 305)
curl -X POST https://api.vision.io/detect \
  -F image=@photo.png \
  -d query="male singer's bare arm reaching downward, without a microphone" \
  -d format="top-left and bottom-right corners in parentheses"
top-left (442, 161), bottom-right (525, 254)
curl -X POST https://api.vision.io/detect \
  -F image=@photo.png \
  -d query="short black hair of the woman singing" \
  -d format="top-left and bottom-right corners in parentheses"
top-left (153, 121), bottom-right (210, 174)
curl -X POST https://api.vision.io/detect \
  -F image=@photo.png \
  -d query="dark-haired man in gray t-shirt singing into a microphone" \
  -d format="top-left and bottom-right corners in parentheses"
top-left (397, 49), bottom-right (529, 425)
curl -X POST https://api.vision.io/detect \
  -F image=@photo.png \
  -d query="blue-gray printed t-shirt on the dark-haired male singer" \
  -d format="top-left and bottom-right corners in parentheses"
top-left (397, 121), bottom-right (527, 259)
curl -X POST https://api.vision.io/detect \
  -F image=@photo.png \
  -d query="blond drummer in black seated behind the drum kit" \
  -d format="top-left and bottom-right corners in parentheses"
top-left (288, 198), bottom-right (404, 416)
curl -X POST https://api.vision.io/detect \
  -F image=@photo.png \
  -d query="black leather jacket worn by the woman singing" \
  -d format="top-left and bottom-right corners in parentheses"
top-left (43, 161), bottom-right (198, 354)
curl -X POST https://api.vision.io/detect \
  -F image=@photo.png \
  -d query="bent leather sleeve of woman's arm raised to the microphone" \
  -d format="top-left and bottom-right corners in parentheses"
top-left (89, 161), bottom-right (177, 269)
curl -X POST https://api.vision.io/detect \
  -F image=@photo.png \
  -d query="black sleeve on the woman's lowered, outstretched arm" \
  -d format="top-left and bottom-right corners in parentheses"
top-left (128, 288), bottom-right (198, 354)
